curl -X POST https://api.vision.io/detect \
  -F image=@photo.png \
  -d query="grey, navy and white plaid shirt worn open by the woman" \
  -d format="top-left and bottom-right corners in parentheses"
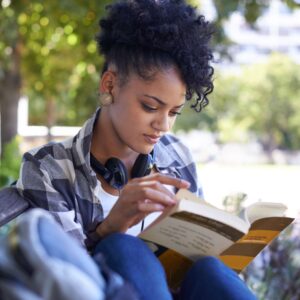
top-left (16, 109), bottom-right (202, 249)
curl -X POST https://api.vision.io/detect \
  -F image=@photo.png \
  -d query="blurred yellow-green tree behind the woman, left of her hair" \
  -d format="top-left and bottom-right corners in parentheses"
top-left (0, 0), bottom-right (112, 152)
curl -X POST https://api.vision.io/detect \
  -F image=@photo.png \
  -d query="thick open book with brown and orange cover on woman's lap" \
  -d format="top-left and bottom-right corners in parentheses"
top-left (139, 190), bottom-right (294, 288)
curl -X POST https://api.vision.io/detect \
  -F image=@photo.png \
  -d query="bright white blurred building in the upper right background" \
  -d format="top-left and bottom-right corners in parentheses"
top-left (222, 0), bottom-right (300, 67)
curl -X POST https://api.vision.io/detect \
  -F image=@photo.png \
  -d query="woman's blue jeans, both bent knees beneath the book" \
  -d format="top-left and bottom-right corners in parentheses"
top-left (95, 233), bottom-right (256, 300)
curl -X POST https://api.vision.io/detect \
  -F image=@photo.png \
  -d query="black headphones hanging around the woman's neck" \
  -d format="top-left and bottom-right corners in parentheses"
top-left (90, 152), bottom-right (153, 190)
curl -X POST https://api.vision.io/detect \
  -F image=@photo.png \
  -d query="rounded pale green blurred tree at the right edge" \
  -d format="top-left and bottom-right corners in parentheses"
top-left (234, 53), bottom-right (300, 153)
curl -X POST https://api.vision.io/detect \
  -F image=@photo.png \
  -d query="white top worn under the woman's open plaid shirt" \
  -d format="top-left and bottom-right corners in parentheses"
top-left (99, 184), bottom-right (161, 236)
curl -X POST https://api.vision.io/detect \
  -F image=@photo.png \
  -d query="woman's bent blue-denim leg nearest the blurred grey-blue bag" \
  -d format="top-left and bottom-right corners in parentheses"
top-left (94, 233), bottom-right (171, 300)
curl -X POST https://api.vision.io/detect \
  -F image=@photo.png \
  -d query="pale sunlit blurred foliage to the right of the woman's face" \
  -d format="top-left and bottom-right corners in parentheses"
top-left (176, 53), bottom-right (300, 152)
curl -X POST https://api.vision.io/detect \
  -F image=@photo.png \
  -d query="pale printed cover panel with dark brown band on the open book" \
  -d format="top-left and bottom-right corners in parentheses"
top-left (139, 212), bottom-right (244, 260)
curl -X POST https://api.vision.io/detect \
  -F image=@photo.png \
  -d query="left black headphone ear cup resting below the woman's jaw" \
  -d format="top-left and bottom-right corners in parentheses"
top-left (105, 157), bottom-right (128, 190)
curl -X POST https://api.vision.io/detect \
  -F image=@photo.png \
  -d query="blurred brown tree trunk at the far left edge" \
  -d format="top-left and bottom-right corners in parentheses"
top-left (0, 44), bottom-right (21, 156)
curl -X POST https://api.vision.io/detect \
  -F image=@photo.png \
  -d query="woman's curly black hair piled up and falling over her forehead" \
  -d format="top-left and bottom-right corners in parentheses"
top-left (96, 0), bottom-right (214, 112)
